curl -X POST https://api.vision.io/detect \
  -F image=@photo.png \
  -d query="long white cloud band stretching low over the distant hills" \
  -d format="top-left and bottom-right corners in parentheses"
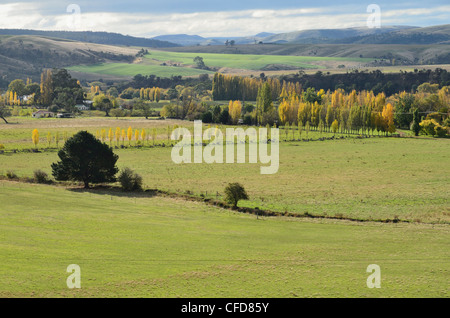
top-left (0, 2), bottom-right (450, 37)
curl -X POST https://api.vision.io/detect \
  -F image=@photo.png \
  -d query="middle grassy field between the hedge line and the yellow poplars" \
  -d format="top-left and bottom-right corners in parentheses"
top-left (0, 126), bottom-right (450, 223)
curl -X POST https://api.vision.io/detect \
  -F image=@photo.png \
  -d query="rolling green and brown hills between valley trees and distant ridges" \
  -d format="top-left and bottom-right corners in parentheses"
top-left (0, 27), bottom-right (450, 84)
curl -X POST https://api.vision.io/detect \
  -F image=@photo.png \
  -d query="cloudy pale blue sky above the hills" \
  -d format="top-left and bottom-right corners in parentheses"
top-left (0, 0), bottom-right (450, 37)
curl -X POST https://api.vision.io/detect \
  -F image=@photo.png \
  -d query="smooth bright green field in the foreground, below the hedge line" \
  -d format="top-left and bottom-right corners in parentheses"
top-left (0, 182), bottom-right (450, 297)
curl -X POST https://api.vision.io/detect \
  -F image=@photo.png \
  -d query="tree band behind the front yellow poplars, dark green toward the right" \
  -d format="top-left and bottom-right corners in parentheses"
top-left (212, 68), bottom-right (450, 101)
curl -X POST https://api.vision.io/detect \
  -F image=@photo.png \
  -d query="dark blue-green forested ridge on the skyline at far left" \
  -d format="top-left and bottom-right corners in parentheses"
top-left (0, 29), bottom-right (180, 48)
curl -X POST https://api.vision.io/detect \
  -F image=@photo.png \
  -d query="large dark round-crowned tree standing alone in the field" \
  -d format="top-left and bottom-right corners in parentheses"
top-left (52, 131), bottom-right (119, 188)
